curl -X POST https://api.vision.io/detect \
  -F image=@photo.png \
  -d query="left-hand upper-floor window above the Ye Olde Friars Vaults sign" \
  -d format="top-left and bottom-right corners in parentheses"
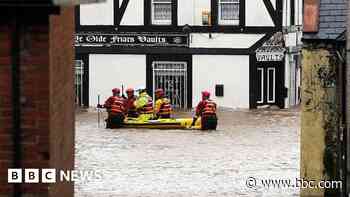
top-left (152, 0), bottom-right (171, 25)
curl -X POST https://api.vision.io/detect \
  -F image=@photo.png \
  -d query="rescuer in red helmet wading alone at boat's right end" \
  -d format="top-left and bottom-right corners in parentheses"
top-left (192, 91), bottom-right (217, 130)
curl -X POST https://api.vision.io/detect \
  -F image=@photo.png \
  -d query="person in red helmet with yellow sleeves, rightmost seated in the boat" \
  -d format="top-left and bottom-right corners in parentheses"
top-left (154, 89), bottom-right (172, 119)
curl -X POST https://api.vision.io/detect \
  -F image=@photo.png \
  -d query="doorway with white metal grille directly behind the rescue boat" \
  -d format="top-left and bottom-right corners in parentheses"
top-left (152, 61), bottom-right (188, 108)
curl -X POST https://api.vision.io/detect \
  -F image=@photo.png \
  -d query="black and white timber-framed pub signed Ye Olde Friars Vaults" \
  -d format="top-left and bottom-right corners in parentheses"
top-left (75, 0), bottom-right (302, 109)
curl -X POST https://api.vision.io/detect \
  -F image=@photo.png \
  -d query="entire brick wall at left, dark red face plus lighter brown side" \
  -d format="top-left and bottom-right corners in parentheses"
top-left (0, 6), bottom-right (74, 197)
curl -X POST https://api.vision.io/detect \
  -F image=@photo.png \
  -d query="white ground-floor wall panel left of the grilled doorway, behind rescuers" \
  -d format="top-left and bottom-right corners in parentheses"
top-left (89, 54), bottom-right (146, 106)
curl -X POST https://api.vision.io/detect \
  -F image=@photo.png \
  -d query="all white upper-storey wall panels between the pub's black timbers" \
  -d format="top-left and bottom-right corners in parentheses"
top-left (80, 0), bottom-right (275, 27)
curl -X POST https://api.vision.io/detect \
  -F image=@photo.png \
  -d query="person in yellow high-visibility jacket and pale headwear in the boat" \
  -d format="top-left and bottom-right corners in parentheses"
top-left (134, 88), bottom-right (153, 121)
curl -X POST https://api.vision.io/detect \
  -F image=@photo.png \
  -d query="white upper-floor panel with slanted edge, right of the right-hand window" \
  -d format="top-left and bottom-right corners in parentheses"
top-left (245, 0), bottom-right (275, 27)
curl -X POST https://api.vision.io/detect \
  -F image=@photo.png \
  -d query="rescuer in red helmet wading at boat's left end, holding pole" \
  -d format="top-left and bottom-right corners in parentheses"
top-left (98, 88), bottom-right (126, 129)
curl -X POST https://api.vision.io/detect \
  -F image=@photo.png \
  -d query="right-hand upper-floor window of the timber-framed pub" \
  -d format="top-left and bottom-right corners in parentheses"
top-left (218, 0), bottom-right (239, 25)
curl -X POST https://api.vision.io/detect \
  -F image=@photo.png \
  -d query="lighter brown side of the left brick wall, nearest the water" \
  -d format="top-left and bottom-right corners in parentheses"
top-left (50, 8), bottom-right (75, 197)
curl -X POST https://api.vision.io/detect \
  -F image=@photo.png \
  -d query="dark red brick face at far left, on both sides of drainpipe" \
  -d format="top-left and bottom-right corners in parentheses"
top-left (0, 24), bottom-right (49, 195)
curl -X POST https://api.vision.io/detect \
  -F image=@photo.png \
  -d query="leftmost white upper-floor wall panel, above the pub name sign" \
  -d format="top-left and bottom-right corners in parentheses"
top-left (80, 0), bottom-right (114, 25)
